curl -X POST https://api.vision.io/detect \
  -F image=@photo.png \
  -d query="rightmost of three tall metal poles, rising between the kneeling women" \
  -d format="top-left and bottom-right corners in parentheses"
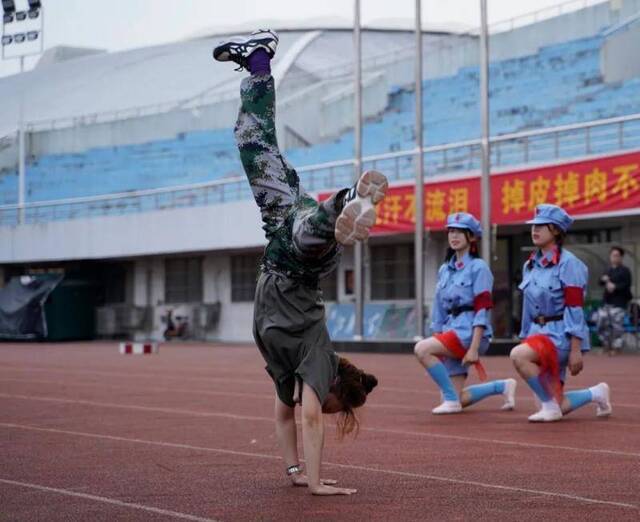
top-left (480, 0), bottom-right (491, 266)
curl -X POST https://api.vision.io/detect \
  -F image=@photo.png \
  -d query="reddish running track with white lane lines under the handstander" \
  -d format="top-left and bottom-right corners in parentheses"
top-left (0, 343), bottom-right (640, 522)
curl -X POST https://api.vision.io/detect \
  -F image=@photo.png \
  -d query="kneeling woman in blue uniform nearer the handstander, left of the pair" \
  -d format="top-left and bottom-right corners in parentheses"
top-left (415, 212), bottom-right (516, 415)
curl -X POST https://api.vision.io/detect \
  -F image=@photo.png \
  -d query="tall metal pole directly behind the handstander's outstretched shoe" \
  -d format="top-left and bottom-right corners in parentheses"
top-left (353, 0), bottom-right (364, 341)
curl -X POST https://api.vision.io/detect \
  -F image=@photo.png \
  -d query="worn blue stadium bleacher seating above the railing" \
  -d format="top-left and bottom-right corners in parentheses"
top-left (0, 32), bottom-right (640, 204)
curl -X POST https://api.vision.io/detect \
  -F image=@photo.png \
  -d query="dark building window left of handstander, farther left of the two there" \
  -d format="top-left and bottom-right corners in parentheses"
top-left (164, 257), bottom-right (202, 303)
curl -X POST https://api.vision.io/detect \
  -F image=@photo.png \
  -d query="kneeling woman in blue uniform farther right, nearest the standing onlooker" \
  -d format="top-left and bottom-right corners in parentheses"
top-left (511, 204), bottom-right (611, 422)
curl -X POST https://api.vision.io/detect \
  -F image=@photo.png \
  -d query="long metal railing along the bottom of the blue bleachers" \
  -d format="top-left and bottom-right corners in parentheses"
top-left (0, 114), bottom-right (640, 226)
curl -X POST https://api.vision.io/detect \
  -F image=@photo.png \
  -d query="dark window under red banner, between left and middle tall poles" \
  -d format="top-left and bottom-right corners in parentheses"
top-left (371, 244), bottom-right (415, 300)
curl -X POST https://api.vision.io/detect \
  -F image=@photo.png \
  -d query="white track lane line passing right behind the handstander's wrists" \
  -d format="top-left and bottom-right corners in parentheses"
top-left (0, 423), bottom-right (640, 510)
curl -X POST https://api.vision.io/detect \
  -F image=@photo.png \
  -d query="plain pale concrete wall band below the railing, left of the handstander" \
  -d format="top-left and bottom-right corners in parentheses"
top-left (0, 196), bottom-right (265, 263)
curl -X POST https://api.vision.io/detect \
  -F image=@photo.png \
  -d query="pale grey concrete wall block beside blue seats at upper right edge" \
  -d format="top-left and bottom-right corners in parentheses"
top-left (600, 22), bottom-right (640, 83)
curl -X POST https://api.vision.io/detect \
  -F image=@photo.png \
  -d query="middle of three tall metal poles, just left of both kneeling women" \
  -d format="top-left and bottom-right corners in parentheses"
top-left (414, 0), bottom-right (424, 339)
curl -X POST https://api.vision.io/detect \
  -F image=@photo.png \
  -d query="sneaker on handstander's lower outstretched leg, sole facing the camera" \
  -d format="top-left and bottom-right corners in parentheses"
top-left (335, 170), bottom-right (389, 245)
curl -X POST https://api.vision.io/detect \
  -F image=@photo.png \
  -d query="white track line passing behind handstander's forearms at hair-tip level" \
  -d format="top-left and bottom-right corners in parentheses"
top-left (0, 393), bottom-right (640, 458)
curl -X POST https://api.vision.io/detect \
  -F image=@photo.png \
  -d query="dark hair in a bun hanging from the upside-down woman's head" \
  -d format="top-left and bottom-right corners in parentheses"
top-left (332, 357), bottom-right (378, 439)
